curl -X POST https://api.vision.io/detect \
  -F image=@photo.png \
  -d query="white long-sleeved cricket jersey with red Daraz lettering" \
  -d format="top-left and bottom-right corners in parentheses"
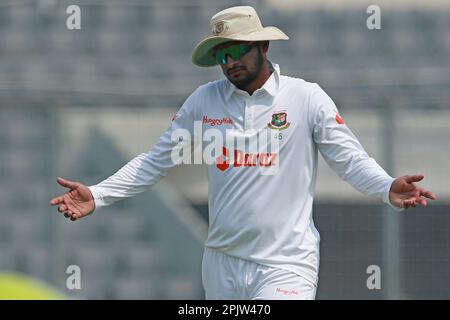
top-left (90, 63), bottom-right (400, 282)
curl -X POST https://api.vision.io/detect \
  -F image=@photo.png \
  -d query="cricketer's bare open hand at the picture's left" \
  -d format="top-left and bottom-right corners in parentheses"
top-left (50, 178), bottom-right (95, 221)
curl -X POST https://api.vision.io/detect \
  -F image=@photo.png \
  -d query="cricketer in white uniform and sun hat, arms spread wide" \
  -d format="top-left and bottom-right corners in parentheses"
top-left (52, 7), bottom-right (435, 299)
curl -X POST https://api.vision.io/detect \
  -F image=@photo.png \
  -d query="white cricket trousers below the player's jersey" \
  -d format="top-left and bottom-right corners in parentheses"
top-left (202, 248), bottom-right (317, 300)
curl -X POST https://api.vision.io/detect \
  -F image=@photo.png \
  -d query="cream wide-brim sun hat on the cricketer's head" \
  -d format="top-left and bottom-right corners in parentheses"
top-left (192, 6), bottom-right (289, 67)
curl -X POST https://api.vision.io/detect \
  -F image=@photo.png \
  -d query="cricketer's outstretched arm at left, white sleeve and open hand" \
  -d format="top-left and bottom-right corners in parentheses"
top-left (50, 92), bottom-right (197, 221)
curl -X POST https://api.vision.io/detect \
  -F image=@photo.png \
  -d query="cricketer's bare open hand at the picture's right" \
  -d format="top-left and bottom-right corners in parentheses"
top-left (389, 174), bottom-right (436, 209)
